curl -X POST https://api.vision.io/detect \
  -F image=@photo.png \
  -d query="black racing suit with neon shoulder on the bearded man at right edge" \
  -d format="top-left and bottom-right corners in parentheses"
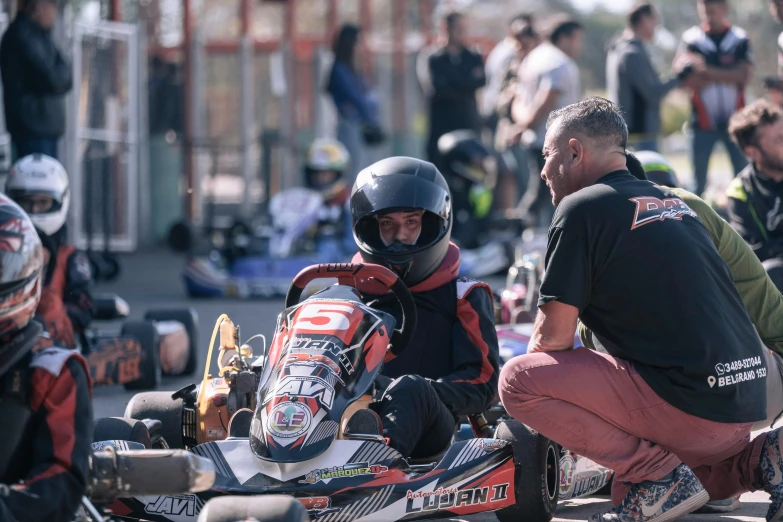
top-left (726, 164), bottom-right (783, 291)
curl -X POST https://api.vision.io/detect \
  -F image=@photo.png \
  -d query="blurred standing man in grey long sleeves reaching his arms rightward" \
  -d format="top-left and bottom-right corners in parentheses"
top-left (606, 2), bottom-right (696, 151)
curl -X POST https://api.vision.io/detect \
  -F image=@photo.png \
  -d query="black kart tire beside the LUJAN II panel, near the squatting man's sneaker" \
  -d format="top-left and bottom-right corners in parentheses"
top-left (495, 420), bottom-right (560, 522)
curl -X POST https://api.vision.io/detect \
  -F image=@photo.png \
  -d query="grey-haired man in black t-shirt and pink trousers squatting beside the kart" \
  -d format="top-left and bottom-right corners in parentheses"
top-left (500, 98), bottom-right (783, 522)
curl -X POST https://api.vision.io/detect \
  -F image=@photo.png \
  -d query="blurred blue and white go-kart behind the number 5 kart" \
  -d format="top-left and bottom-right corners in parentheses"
top-left (183, 187), bottom-right (356, 298)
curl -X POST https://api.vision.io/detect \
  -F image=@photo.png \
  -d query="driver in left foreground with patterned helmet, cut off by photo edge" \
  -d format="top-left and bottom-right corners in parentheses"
top-left (0, 191), bottom-right (92, 522)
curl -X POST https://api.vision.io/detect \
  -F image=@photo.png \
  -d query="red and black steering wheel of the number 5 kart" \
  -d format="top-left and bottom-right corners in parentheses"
top-left (285, 263), bottom-right (416, 356)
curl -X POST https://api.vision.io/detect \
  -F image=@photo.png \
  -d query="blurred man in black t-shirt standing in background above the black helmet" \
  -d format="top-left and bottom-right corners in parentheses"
top-left (417, 11), bottom-right (486, 171)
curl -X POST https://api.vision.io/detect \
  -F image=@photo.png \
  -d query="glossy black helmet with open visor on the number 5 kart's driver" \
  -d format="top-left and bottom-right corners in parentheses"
top-left (351, 156), bottom-right (452, 286)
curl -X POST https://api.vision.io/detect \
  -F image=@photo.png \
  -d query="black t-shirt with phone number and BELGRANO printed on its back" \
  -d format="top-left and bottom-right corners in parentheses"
top-left (539, 171), bottom-right (767, 423)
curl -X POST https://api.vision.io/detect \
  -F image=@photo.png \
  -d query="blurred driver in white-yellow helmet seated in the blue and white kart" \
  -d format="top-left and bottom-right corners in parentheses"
top-left (305, 138), bottom-right (356, 252)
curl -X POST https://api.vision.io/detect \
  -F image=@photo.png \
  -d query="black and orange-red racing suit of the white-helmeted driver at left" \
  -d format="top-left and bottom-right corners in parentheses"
top-left (36, 229), bottom-right (92, 350)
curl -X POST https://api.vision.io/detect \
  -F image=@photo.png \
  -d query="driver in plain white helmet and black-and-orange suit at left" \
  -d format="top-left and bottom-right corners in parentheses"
top-left (6, 154), bottom-right (92, 349)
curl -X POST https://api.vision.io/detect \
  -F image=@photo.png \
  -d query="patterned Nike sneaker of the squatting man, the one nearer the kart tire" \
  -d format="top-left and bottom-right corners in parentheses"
top-left (590, 464), bottom-right (710, 522)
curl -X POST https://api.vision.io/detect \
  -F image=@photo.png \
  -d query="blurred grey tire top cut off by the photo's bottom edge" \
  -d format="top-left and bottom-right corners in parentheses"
top-left (198, 495), bottom-right (310, 522)
